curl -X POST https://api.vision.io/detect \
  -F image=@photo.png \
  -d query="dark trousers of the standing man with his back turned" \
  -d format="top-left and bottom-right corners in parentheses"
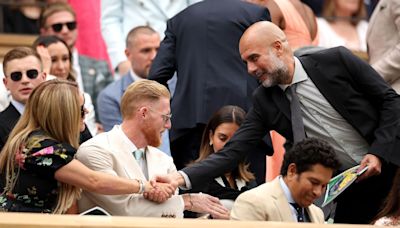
top-left (170, 124), bottom-right (269, 185)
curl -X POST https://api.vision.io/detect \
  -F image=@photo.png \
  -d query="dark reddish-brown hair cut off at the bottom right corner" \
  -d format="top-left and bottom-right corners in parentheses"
top-left (375, 169), bottom-right (400, 223)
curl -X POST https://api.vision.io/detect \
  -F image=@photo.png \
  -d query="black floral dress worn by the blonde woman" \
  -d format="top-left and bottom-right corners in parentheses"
top-left (0, 131), bottom-right (76, 213)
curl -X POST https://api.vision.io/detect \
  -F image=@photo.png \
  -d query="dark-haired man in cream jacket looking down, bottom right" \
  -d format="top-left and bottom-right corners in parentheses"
top-left (231, 138), bottom-right (339, 223)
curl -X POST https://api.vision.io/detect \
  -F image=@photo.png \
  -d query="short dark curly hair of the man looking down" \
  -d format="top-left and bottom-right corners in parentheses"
top-left (281, 138), bottom-right (340, 176)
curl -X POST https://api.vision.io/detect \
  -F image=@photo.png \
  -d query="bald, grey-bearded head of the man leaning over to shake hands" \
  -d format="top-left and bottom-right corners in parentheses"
top-left (239, 21), bottom-right (294, 87)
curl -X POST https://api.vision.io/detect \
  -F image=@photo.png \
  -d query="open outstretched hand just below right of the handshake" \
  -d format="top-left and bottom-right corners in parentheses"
top-left (183, 193), bottom-right (229, 219)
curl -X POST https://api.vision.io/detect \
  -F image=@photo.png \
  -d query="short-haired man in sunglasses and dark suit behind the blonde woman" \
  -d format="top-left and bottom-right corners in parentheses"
top-left (0, 47), bottom-right (46, 149)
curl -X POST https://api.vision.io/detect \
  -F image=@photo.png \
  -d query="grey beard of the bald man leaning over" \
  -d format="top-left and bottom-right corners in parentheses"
top-left (262, 52), bottom-right (290, 88)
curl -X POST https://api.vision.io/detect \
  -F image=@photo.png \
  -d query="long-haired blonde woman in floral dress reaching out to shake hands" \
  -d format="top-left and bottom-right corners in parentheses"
top-left (0, 79), bottom-right (174, 214)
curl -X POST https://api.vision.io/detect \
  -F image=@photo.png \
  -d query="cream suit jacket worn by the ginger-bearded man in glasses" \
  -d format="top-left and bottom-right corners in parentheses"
top-left (76, 126), bottom-right (184, 218)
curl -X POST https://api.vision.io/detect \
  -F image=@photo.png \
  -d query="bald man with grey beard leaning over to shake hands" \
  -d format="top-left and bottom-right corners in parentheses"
top-left (158, 22), bottom-right (400, 224)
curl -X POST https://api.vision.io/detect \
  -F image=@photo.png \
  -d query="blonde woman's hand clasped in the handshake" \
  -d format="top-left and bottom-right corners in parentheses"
top-left (143, 181), bottom-right (175, 203)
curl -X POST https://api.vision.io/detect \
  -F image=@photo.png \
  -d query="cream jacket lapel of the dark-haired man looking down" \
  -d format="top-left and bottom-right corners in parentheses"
top-left (271, 177), bottom-right (297, 222)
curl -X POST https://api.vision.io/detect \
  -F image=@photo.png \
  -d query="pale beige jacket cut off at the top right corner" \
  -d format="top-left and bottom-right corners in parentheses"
top-left (367, 0), bottom-right (400, 93)
